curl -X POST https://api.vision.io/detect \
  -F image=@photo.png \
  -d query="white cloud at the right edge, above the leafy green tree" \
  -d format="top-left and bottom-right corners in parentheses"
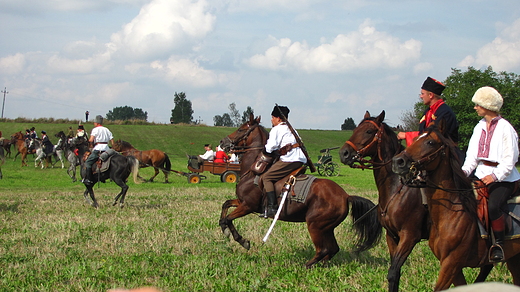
top-left (458, 19), bottom-right (520, 71)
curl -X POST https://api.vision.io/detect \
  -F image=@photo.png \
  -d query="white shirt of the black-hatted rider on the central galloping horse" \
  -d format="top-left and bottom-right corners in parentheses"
top-left (265, 123), bottom-right (307, 163)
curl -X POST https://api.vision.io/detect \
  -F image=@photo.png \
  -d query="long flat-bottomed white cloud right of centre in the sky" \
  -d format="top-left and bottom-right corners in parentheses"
top-left (244, 21), bottom-right (422, 73)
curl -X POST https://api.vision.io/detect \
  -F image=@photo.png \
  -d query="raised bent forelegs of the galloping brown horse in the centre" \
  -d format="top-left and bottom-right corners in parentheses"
top-left (218, 199), bottom-right (252, 250)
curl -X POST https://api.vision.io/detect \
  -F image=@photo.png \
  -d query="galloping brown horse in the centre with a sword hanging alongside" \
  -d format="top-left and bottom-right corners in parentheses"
top-left (219, 114), bottom-right (382, 268)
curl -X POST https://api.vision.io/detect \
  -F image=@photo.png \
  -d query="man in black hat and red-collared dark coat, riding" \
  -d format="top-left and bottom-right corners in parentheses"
top-left (397, 77), bottom-right (459, 146)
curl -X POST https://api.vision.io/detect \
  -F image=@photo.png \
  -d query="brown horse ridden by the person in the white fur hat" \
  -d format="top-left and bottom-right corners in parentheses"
top-left (392, 122), bottom-right (520, 291)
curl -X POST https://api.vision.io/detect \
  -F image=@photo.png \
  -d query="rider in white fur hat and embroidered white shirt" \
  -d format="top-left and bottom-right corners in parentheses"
top-left (462, 86), bottom-right (520, 262)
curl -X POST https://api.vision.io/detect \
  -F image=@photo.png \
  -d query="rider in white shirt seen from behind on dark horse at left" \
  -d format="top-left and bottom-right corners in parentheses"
top-left (82, 115), bottom-right (114, 184)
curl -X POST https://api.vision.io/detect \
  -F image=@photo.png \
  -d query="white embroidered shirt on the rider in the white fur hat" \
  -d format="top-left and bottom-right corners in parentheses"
top-left (462, 117), bottom-right (520, 182)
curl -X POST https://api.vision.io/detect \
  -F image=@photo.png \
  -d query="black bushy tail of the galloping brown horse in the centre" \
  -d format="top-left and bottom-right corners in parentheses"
top-left (347, 196), bottom-right (383, 252)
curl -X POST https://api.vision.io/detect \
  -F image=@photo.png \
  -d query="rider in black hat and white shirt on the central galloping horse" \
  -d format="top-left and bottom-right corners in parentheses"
top-left (260, 106), bottom-right (307, 217)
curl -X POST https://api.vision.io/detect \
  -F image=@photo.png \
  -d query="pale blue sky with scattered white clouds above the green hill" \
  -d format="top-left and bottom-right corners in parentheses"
top-left (0, 0), bottom-right (520, 130)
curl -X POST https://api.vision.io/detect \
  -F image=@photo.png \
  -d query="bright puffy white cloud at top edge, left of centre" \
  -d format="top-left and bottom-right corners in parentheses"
top-left (108, 0), bottom-right (216, 59)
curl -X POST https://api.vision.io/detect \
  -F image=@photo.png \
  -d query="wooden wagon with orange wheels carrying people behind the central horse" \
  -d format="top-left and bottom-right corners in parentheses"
top-left (186, 158), bottom-right (240, 183)
